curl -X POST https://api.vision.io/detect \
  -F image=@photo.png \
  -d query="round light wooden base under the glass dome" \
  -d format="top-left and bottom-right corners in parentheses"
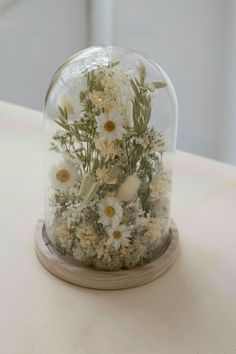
top-left (35, 220), bottom-right (178, 290)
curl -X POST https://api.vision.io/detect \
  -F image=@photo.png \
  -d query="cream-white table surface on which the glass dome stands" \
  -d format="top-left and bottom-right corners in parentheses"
top-left (0, 102), bottom-right (236, 354)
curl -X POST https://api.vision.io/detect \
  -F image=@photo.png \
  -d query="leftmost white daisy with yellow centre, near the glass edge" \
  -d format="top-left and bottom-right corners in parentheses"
top-left (49, 161), bottom-right (78, 191)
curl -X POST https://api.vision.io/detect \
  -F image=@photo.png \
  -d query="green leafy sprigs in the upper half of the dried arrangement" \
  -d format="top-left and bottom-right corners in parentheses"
top-left (51, 62), bottom-right (166, 205)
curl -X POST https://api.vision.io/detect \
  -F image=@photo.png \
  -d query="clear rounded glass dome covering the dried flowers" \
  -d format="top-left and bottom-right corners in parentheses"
top-left (44, 47), bottom-right (177, 271)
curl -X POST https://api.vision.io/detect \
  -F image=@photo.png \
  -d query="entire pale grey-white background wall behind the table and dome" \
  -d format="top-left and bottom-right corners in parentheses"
top-left (0, 0), bottom-right (236, 164)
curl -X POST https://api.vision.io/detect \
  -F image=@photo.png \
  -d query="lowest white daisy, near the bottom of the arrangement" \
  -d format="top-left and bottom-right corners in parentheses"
top-left (107, 225), bottom-right (130, 250)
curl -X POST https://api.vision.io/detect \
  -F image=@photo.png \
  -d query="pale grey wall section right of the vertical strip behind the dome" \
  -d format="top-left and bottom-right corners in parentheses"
top-left (109, 0), bottom-right (236, 163)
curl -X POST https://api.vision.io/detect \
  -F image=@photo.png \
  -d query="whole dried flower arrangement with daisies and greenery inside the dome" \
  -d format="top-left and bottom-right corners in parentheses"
top-left (47, 62), bottom-right (171, 271)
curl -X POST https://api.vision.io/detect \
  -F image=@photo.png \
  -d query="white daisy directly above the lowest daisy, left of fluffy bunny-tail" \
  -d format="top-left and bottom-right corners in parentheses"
top-left (98, 197), bottom-right (122, 227)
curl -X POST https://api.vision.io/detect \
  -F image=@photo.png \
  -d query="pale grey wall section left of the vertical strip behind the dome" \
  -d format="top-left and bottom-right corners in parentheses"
top-left (0, 0), bottom-right (88, 110)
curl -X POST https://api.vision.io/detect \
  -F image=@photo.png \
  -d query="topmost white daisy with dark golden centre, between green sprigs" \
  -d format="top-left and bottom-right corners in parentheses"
top-left (97, 111), bottom-right (125, 141)
